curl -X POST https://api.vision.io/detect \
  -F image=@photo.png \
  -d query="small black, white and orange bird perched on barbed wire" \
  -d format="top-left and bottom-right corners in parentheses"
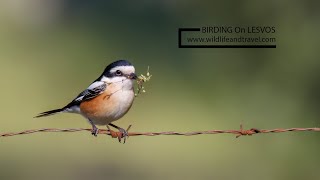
top-left (35, 60), bottom-right (137, 142)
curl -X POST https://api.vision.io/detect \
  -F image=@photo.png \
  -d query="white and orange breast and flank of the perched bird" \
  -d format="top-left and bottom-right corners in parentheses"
top-left (80, 84), bottom-right (134, 125)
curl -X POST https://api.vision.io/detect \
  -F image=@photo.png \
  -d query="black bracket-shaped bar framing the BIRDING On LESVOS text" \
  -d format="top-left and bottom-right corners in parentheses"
top-left (178, 28), bottom-right (277, 48)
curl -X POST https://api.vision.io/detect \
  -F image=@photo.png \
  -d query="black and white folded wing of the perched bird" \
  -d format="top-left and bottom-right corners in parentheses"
top-left (65, 81), bottom-right (107, 108)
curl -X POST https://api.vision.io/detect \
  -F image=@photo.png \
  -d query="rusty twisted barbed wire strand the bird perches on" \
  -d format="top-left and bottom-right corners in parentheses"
top-left (0, 125), bottom-right (320, 141)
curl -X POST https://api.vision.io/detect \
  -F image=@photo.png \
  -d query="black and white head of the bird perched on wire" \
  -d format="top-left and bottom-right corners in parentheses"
top-left (100, 60), bottom-right (137, 88)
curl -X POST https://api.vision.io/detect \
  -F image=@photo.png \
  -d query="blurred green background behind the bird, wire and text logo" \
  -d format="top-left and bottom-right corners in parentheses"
top-left (0, 0), bottom-right (320, 180)
